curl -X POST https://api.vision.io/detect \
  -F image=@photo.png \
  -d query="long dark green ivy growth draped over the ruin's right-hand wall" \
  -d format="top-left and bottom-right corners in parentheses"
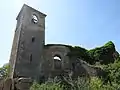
top-left (68, 41), bottom-right (119, 64)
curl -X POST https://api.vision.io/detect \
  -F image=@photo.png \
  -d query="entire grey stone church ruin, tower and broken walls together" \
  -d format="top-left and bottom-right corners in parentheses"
top-left (0, 4), bottom-right (111, 90)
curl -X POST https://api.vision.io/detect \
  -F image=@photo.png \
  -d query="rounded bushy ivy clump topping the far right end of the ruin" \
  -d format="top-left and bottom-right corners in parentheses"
top-left (88, 41), bottom-right (117, 64)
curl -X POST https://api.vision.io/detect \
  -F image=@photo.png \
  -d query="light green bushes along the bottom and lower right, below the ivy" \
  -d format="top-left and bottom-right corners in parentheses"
top-left (30, 59), bottom-right (120, 90)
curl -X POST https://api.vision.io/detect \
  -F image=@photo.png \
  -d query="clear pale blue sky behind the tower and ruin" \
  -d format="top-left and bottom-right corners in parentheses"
top-left (0, 0), bottom-right (120, 66)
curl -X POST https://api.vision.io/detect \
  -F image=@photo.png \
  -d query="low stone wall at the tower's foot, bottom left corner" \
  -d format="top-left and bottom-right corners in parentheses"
top-left (0, 78), bottom-right (33, 90)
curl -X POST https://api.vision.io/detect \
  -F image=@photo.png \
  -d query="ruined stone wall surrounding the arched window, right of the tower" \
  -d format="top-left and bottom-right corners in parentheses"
top-left (41, 44), bottom-right (70, 76)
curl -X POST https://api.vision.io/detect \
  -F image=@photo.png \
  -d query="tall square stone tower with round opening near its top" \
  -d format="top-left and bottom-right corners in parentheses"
top-left (9, 4), bottom-right (46, 79)
